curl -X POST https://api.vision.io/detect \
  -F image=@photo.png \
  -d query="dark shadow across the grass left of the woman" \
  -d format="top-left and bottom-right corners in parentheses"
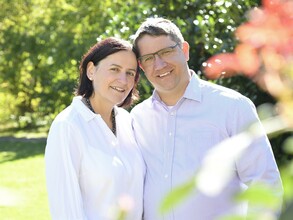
top-left (0, 136), bottom-right (46, 164)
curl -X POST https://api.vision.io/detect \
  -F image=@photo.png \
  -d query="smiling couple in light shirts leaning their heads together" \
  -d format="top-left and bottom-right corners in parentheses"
top-left (45, 18), bottom-right (281, 220)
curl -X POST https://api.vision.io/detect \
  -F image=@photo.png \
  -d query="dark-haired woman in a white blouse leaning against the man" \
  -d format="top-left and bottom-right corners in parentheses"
top-left (45, 38), bottom-right (145, 220)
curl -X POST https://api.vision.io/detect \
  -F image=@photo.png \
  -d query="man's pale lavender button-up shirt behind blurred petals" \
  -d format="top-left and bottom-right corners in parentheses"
top-left (131, 74), bottom-right (281, 220)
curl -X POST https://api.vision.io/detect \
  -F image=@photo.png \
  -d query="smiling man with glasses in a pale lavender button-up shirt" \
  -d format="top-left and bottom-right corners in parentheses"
top-left (131, 18), bottom-right (281, 220)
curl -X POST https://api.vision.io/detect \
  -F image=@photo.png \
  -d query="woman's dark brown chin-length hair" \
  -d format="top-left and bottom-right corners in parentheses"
top-left (75, 37), bottom-right (139, 108)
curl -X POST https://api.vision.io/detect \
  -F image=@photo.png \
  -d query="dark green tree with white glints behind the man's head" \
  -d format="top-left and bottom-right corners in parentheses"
top-left (97, 0), bottom-right (264, 105)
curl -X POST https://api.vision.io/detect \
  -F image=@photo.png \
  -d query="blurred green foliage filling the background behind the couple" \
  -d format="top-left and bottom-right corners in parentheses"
top-left (0, 0), bottom-right (259, 127)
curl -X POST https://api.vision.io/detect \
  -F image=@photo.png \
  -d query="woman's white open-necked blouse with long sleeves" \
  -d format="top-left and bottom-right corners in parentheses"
top-left (45, 96), bottom-right (145, 220)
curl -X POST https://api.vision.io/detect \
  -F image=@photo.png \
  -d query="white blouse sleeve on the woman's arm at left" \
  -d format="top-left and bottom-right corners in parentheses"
top-left (45, 121), bottom-right (86, 220)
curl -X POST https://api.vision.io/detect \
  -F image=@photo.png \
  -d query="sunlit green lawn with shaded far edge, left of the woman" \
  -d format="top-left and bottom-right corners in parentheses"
top-left (0, 137), bottom-right (50, 220)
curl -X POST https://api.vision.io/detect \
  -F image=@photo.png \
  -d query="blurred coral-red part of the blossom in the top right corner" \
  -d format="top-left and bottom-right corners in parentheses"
top-left (203, 0), bottom-right (293, 79)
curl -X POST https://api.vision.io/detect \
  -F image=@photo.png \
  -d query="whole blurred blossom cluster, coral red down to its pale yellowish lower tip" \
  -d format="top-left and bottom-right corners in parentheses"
top-left (203, 0), bottom-right (293, 124)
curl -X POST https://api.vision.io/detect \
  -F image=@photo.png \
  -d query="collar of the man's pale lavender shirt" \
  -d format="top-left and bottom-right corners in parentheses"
top-left (152, 70), bottom-right (201, 103)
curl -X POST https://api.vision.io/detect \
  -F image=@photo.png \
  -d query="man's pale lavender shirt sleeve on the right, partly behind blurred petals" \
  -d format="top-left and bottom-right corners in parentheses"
top-left (235, 98), bottom-right (283, 215)
